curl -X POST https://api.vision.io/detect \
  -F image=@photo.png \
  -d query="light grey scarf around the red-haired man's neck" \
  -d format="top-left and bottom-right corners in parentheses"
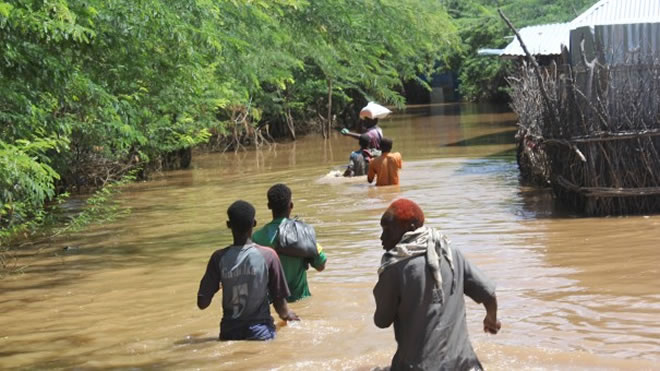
top-left (378, 227), bottom-right (456, 303)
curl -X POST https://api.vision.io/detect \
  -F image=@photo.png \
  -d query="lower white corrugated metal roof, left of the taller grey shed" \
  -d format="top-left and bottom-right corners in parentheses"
top-left (500, 23), bottom-right (568, 56)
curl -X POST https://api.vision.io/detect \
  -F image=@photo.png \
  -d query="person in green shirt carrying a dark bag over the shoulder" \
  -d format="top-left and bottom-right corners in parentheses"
top-left (252, 184), bottom-right (327, 303)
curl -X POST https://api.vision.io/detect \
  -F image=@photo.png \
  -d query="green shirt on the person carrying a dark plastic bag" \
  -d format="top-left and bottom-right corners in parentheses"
top-left (252, 218), bottom-right (327, 302)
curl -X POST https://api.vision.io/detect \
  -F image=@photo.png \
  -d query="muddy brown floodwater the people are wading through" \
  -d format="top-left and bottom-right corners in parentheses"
top-left (0, 105), bottom-right (660, 370)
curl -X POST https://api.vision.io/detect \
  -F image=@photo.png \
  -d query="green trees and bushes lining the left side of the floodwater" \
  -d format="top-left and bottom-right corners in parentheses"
top-left (0, 0), bottom-right (458, 241)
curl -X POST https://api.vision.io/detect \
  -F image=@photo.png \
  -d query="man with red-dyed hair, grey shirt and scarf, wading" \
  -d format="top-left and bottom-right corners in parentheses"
top-left (374, 199), bottom-right (501, 370)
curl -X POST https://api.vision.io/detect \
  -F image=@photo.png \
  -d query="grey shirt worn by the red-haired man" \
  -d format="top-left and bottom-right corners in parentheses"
top-left (374, 248), bottom-right (495, 370)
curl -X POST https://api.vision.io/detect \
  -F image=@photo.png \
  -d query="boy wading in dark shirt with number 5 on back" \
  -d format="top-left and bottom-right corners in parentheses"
top-left (197, 201), bottom-right (299, 340)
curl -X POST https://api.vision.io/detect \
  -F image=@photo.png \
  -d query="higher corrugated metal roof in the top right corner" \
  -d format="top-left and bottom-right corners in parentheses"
top-left (571, 0), bottom-right (660, 29)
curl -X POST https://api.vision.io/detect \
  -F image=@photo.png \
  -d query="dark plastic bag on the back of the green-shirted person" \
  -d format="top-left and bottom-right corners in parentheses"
top-left (275, 218), bottom-right (319, 258)
